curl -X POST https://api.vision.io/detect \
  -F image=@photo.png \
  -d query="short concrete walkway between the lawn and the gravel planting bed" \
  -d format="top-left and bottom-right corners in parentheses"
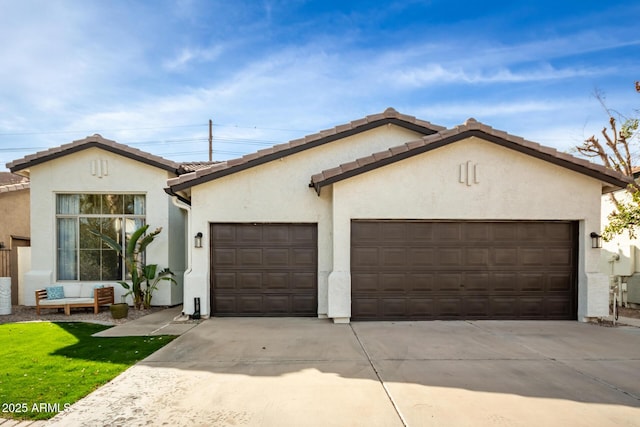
top-left (93, 305), bottom-right (197, 337)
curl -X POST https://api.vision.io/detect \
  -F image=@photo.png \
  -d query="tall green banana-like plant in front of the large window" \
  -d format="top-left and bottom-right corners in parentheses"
top-left (92, 224), bottom-right (177, 310)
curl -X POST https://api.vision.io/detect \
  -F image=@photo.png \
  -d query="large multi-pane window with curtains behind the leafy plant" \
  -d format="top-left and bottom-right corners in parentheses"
top-left (56, 194), bottom-right (145, 281)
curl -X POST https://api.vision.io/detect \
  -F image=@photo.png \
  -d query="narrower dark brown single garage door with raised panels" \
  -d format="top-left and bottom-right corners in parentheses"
top-left (211, 224), bottom-right (318, 316)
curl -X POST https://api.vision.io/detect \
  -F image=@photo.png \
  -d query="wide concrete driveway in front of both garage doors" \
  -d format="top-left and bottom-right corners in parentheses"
top-left (46, 318), bottom-right (640, 427)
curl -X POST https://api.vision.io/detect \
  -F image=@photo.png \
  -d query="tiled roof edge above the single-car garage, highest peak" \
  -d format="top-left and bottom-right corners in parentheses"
top-left (168, 108), bottom-right (445, 193)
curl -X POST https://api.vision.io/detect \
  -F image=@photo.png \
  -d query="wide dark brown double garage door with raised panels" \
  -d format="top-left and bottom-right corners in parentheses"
top-left (351, 221), bottom-right (577, 320)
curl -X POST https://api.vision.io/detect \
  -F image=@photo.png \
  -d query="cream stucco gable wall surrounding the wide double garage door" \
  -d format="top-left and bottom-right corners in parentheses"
top-left (329, 137), bottom-right (608, 319)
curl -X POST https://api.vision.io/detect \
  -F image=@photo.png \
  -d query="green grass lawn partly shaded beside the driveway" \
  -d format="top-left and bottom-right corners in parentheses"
top-left (0, 322), bottom-right (175, 420)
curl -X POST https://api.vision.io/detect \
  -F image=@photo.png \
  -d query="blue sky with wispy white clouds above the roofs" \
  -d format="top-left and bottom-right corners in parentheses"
top-left (0, 0), bottom-right (640, 170)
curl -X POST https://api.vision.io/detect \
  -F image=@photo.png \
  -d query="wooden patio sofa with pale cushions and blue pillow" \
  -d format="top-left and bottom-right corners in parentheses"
top-left (36, 283), bottom-right (113, 316)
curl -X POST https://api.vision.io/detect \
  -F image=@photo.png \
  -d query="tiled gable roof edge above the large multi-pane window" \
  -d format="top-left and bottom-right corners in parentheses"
top-left (7, 134), bottom-right (180, 174)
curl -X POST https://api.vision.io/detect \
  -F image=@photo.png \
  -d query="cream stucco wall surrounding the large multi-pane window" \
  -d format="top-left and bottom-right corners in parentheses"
top-left (23, 148), bottom-right (185, 305)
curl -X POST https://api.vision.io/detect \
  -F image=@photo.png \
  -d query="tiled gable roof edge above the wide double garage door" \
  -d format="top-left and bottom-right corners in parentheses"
top-left (309, 118), bottom-right (633, 194)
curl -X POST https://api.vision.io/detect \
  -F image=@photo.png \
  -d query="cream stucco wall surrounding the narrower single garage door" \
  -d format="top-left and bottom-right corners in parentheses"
top-left (184, 125), bottom-right (428, 317)
